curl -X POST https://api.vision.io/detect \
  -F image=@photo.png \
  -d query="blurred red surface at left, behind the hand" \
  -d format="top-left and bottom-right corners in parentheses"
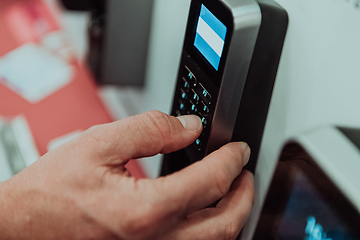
top-left (0, 0), bottom-right (145, 178)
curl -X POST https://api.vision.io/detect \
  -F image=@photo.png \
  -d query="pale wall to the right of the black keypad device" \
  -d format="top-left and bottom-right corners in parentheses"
top-left (242, 0), bottom-right (360, 239)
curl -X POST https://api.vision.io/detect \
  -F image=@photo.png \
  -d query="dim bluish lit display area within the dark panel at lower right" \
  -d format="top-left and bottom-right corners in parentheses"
top-left (277, 171), bottom-right (358, 240)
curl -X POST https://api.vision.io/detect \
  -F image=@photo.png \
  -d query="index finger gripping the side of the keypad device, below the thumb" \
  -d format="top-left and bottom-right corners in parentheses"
top-left (158, 142), bottom-right (250, 216)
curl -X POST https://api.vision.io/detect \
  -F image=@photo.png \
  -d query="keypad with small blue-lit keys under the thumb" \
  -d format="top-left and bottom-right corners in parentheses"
top-left (176, 66), bottom-right (212, 150)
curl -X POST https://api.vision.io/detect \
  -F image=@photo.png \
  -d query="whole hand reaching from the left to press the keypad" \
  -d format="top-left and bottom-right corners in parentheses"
top-left (0, 111), bottom-right (254, 240)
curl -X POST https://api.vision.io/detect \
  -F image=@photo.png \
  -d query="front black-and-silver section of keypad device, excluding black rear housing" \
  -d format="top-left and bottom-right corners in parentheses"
top-left (163, 0), bottom-right (261, 165)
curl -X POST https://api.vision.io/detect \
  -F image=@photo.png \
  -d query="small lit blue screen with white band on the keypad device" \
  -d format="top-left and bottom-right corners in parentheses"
top-left (194, 4), bottom-right (227, 71)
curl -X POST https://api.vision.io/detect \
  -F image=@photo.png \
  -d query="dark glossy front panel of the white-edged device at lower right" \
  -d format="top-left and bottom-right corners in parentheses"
top-left (253, 144), bottom-right (360, 240)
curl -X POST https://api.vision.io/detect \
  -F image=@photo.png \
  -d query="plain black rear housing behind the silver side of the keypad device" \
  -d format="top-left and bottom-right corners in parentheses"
top-left (231, 0), bottom-right (288, 172)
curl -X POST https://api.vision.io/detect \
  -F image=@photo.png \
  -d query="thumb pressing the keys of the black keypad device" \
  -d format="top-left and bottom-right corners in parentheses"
top-left (82, 111), bottom-right (202, 164)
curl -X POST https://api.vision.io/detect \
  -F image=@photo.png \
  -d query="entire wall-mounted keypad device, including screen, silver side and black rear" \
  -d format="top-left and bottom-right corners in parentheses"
top-left (162, 0), bottom-right (287, 175)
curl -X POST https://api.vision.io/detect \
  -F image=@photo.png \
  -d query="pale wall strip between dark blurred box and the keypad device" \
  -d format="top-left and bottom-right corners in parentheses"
top-left (136, 0), bottom-right (190, 177)
